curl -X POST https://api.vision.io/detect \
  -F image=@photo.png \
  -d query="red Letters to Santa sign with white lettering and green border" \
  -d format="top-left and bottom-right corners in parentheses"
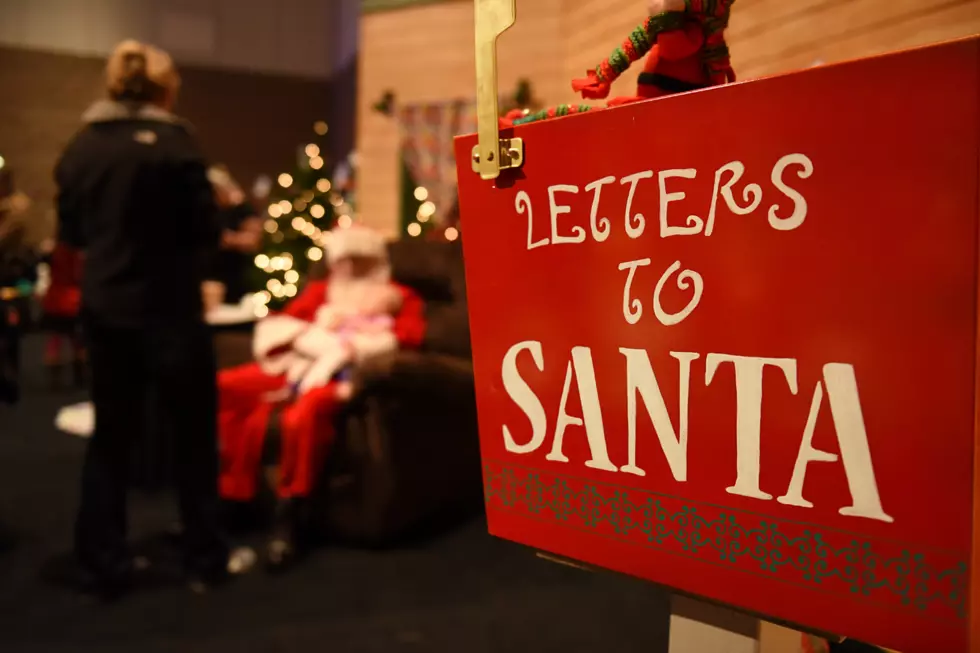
top-left (456, 39), bottom-right (980, 653)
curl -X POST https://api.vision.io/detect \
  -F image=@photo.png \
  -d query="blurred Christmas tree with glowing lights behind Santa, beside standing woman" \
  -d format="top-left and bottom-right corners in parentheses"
top-left (252, 122), bottom-right (356, 317)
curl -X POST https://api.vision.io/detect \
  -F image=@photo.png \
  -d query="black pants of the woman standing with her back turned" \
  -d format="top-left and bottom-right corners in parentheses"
top-left (75, 316), bottom-right (228, 582)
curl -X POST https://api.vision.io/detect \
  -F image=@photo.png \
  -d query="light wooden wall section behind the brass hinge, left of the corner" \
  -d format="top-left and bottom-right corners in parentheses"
top-left (357, 0), bottom-right (566, 235)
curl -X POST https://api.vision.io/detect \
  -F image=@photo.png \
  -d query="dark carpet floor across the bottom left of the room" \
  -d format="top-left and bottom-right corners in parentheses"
top-left (0, 338), bottom-right (669, 653)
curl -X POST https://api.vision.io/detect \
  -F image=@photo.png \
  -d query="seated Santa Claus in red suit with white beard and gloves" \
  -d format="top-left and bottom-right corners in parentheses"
top-left (218, 227), bottom-right (425, 567)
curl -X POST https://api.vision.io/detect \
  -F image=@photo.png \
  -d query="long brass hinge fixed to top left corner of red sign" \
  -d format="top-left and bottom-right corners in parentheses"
top-left (473, 0), bottom-right (524, 179)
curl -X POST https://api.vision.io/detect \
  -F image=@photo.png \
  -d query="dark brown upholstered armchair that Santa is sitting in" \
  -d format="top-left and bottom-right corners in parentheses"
top-left (314, 240), bottom-right (482, 545)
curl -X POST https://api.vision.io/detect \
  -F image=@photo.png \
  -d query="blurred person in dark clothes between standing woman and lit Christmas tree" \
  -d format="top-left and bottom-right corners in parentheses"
top-left (208, 165), bottom-right (262, 304)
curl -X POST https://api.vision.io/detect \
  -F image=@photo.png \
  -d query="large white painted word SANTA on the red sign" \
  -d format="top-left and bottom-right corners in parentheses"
top-left (500, 340), bottom-right (894, 522)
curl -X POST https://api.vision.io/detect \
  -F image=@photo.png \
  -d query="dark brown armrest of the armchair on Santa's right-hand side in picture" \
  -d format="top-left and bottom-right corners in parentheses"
top-left (324, 351), bottom-right (482, 546)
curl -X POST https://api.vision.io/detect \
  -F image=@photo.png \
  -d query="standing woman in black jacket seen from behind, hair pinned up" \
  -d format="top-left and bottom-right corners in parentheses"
top-left (55, 41), bottom-right (228, 596)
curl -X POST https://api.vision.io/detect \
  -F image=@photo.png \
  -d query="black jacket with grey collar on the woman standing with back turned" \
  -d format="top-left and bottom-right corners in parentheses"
top-left (55, 100), bottom-right (221, 327)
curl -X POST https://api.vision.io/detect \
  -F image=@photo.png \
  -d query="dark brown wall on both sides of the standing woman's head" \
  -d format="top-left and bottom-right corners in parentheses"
top-left (0, 47), bottom-right (334, 247)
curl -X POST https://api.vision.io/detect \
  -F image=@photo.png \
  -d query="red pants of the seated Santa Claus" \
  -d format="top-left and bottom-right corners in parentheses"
top-left (218, 363), bottom-right (339, 501)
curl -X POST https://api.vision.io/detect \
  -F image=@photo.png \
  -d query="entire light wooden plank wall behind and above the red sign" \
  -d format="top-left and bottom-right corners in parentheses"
top-left (358, 0), bottom-right (980, 233)
